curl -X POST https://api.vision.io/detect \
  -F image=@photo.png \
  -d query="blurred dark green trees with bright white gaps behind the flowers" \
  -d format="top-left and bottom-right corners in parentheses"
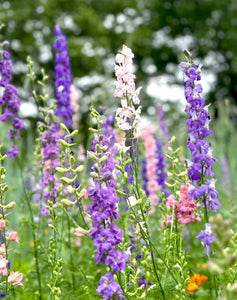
top-left (0, 0), bottom-right (237, 120)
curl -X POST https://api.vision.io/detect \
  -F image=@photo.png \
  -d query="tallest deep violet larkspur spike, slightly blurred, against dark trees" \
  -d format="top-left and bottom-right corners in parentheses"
top-left (53, 25), bottom-right (73, 127)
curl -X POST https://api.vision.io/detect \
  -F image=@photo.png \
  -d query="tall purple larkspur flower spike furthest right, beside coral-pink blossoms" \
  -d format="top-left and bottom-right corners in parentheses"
top-left (180, 50), bottom-right (220, 254)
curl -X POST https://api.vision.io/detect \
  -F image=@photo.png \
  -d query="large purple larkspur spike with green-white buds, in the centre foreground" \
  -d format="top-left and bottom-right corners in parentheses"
top-left (88, 115), bottom-right (129, 299)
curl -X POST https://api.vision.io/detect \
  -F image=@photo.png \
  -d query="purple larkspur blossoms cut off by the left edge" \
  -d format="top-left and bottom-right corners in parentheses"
top-left (0, 50), bottom-right (24, 157)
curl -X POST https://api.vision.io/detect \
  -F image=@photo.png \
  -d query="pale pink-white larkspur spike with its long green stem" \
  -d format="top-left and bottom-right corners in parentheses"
top-left (114, 45), bottom-right (165, 299)
